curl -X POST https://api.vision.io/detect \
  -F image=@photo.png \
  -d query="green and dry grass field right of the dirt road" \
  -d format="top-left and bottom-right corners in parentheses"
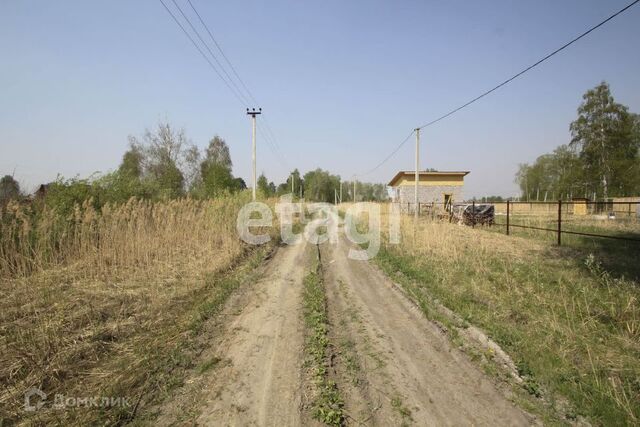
top-left (377, 206), bottom-right (640, 425)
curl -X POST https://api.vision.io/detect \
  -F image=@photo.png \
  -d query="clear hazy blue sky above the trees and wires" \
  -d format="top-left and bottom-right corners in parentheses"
top-left (0, 0), bottom-right (640, 197)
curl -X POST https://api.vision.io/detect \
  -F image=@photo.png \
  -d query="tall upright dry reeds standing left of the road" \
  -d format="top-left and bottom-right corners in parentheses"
top-left (0, 199), bottom-right (239, 278)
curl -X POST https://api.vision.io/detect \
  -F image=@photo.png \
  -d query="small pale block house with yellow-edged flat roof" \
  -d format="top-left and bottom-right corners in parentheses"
top-left (388, 171), bottom-right (469, 211)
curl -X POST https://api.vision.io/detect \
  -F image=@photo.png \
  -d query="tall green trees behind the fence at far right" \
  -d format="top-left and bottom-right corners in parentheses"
top-left (515, 82), bottom-right (640, 200)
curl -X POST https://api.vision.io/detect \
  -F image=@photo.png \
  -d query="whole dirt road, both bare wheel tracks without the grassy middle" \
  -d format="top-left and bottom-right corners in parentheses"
top-left (162, 224), bottom-right (537, 426)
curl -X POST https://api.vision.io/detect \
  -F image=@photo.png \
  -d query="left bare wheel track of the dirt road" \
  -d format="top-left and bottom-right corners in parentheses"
top-left (197, 244), bottom-right (307, 426)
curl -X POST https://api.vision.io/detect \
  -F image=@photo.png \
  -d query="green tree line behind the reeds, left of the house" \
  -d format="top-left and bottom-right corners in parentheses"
top-left (0, 123), bottom-right (387, 211)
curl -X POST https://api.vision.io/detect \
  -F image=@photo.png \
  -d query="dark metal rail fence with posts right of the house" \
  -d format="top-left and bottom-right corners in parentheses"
top-left (490, 200), bottom-right (640, 245)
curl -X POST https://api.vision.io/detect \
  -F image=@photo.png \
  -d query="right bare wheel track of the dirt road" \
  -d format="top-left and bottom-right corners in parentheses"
top-left (321, 237), bottom-right (537, 426)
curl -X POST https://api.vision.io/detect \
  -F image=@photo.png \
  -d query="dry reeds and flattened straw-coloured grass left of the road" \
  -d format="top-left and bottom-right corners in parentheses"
top-left (0, 197), bottom-right (255, 420)
